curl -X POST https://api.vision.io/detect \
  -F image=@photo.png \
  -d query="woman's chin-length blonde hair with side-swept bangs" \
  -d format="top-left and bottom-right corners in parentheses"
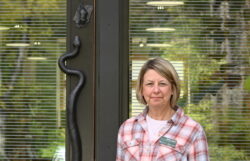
top-left (136, 57), bottom-right (180, 109)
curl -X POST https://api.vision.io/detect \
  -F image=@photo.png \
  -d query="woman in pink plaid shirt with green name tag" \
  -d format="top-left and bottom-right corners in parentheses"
top-left (116, 58), bottom-right (209, 161)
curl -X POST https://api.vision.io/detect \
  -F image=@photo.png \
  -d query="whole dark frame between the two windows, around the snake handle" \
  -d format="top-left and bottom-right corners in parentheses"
top-left (66, 0), bottom-right (129, 161)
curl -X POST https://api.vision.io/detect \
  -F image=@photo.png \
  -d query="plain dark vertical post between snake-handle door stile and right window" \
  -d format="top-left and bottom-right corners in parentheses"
top-left (95, 0), bottom-right (129, 161)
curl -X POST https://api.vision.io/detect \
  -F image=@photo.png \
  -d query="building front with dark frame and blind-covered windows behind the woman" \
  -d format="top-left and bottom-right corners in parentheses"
top-left (0, 0), bottom-right (250, 161)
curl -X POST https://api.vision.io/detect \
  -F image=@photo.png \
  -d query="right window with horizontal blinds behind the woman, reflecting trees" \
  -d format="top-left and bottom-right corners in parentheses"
top-left (129, 0), bottom-right (250, 161)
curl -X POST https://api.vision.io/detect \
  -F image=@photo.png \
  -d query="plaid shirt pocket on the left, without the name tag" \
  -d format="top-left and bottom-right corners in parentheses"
top-left (122, 140), bottom-right (140, 161)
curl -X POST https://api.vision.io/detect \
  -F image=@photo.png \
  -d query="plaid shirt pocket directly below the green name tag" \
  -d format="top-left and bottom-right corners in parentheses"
top-left (156, 144), bottom-right (184, 161)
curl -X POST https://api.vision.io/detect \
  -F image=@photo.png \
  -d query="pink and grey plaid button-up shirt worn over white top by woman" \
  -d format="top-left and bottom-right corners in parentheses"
top-left (116, 108), bottom-right (209, 161)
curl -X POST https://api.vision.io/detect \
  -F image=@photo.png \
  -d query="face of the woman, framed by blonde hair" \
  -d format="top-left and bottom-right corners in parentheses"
top-left (142, 69), bottom-right (173, 107)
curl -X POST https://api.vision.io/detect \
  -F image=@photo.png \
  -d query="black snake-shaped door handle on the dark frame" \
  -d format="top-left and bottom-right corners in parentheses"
top-left (58, 36), bottom-right (85, 161)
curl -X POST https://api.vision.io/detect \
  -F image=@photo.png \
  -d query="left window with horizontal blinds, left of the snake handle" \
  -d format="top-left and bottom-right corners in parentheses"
top-left (0, 0), bottom-right (66, 161)
